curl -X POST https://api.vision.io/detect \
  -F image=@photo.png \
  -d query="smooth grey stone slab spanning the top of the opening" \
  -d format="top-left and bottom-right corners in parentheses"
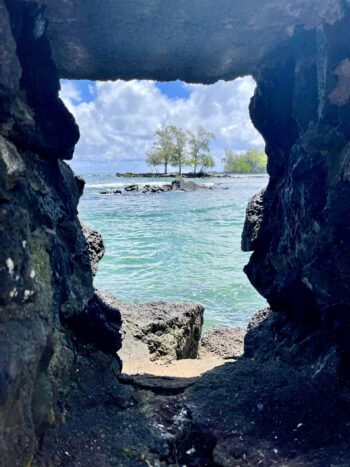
top-left (42, 0), bottom-right (348, 83)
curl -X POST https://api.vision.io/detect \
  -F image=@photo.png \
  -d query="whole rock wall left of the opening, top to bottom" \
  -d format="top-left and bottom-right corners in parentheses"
top-left (0, 0), bottom-right (120, 466)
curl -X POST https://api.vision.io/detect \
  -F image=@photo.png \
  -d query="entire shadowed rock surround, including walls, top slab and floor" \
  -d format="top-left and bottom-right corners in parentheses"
top-left (0, 0), bottom-right (350, 466)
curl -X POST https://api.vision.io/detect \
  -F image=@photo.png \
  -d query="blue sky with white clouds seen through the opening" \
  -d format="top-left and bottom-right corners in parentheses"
top-left (60, 77), bottom-right (264, 174)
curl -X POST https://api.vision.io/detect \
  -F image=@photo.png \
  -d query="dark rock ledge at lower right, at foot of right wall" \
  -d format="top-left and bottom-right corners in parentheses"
top-left (244, 308), bottom-right (350, 407)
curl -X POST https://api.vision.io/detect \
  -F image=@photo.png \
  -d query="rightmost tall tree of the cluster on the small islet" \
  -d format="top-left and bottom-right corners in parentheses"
top-left (188, 127), bottom-right (215, 173)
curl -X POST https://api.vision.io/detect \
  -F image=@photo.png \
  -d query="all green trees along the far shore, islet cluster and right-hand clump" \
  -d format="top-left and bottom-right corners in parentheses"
top-left (135, 125), bottom-right (267, 178)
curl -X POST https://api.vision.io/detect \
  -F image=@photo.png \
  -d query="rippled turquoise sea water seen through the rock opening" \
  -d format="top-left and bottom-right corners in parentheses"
top-left (79, 175), bottom-right (268, 328)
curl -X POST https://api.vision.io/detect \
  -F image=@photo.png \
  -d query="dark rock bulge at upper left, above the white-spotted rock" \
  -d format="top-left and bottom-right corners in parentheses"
top-left (4, 1), bottom-right (79, 159)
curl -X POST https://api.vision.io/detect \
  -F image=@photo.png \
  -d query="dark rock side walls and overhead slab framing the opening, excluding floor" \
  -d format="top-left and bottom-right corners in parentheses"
top-left (0, 0), bottom-right (350, 465)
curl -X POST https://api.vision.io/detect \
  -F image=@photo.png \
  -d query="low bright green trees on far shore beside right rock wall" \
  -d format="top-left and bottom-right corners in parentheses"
top-left (222, 148), bottom-right (267, 174)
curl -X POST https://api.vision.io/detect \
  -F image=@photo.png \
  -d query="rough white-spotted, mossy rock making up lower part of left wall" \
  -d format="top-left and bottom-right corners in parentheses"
top-left (0, 137), bottom-right (93, 465)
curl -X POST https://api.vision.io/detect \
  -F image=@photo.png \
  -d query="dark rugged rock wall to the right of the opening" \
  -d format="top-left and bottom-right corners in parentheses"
top-left (245, 16), bottom-right (350, 384)
